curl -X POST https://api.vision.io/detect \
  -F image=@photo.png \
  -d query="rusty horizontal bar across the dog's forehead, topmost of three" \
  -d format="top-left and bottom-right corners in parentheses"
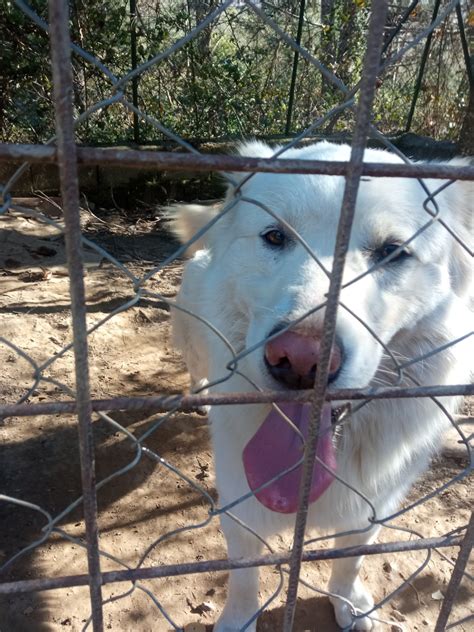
top-left (0, 143), bottom-right (474, 180)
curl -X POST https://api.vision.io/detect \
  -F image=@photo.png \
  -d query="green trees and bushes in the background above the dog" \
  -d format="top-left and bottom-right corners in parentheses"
top-left (0, 0), bottom-right (468, 144)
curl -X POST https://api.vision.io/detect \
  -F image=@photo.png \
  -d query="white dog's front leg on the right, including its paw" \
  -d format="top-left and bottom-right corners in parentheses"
top-left (329, 527), bottom-right (379, 630)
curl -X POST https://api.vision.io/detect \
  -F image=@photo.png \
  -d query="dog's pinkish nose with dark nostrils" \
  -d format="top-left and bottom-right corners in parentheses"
top-left (265, 331), bottom-right (342, 389)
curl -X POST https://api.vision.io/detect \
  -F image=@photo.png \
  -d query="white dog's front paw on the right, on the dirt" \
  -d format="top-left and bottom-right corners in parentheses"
top-left (329, 578), bottom-right (376, 631)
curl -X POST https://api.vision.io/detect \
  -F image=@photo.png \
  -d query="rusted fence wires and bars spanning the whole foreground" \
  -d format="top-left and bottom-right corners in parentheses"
top-left (0, 0), bottom-right (474, 632)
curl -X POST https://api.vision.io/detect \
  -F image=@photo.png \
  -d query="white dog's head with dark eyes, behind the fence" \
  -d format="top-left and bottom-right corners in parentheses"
top-left (169, 142), bottom-right (472, 388)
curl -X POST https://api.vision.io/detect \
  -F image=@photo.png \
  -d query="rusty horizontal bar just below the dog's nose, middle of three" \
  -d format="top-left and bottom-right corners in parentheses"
top-left (0, 384), bottom-right (474, 418)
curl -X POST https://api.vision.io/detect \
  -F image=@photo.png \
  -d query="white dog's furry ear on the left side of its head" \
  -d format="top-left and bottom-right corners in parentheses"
top-left (165, 202), bottom-right (222, 256)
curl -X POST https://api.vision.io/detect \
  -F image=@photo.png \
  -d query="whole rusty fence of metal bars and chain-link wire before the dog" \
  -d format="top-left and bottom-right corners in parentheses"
top-left (0, 0), bottom-right (474, 632)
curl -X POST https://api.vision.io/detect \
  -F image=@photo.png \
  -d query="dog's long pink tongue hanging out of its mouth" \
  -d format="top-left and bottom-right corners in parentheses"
top-left (242, 403), bottom-right (336, 513)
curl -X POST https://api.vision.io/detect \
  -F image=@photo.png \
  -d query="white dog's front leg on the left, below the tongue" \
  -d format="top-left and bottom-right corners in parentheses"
top-left (214, 515), bottom-right (262, 632)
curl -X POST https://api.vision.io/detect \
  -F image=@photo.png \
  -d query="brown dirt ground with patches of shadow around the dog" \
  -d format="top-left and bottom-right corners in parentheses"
top-left (0, 204), bottom-right (473, 632)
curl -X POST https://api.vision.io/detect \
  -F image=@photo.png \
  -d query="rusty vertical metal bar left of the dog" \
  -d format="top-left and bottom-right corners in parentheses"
top-left (49, 0), bottom-right (103, 632)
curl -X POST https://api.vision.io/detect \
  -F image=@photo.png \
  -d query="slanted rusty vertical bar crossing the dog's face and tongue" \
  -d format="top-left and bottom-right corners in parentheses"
top-left (283, 0), bottom-right (387, 632)
